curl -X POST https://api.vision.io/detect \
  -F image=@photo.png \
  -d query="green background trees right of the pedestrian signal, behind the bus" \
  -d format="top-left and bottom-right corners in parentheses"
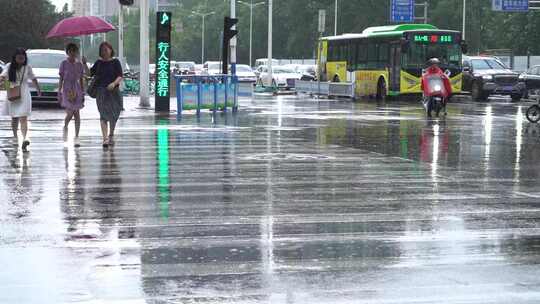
top-left (155, 0), bottom-right (540, 63)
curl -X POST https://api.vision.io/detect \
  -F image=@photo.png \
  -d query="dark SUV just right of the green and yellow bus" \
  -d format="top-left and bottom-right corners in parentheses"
top-left (463, 56), bottom-right (526, 101)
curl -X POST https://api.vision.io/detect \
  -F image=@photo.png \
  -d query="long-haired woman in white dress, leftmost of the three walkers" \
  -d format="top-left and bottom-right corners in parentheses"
top-left (0, 48), bottom-right (41, 151)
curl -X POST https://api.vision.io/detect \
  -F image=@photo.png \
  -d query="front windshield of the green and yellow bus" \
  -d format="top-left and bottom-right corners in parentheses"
top-left (402, 43), bottom-right (461, 69)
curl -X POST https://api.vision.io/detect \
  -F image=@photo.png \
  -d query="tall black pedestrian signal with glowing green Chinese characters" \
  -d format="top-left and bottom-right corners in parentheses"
top-left (155, 12), bottom-right (172, 112)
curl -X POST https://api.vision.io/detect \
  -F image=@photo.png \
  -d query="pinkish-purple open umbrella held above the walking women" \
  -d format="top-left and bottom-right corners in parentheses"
top-left (47, 16), bottom-right (115, 38)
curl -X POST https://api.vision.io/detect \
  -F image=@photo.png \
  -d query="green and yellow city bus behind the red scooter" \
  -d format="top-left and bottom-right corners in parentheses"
top-left (317, 24), bottom-right (466, 99)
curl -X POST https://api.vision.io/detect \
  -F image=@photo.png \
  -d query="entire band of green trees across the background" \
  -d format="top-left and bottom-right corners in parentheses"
top-left (4, 0), bottom-right (540, 65)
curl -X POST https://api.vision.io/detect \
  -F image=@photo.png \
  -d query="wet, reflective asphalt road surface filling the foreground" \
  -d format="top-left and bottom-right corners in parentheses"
top-left (0, 97), bottom-right (540, 304)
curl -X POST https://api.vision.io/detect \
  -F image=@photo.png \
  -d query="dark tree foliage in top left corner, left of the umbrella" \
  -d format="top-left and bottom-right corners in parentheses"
top-left (0, 0), bottom-right (71, 61)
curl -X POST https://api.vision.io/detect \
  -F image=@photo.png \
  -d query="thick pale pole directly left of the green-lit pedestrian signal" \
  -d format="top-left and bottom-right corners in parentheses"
top-left (139, 0), bottom-right (150, 108)
